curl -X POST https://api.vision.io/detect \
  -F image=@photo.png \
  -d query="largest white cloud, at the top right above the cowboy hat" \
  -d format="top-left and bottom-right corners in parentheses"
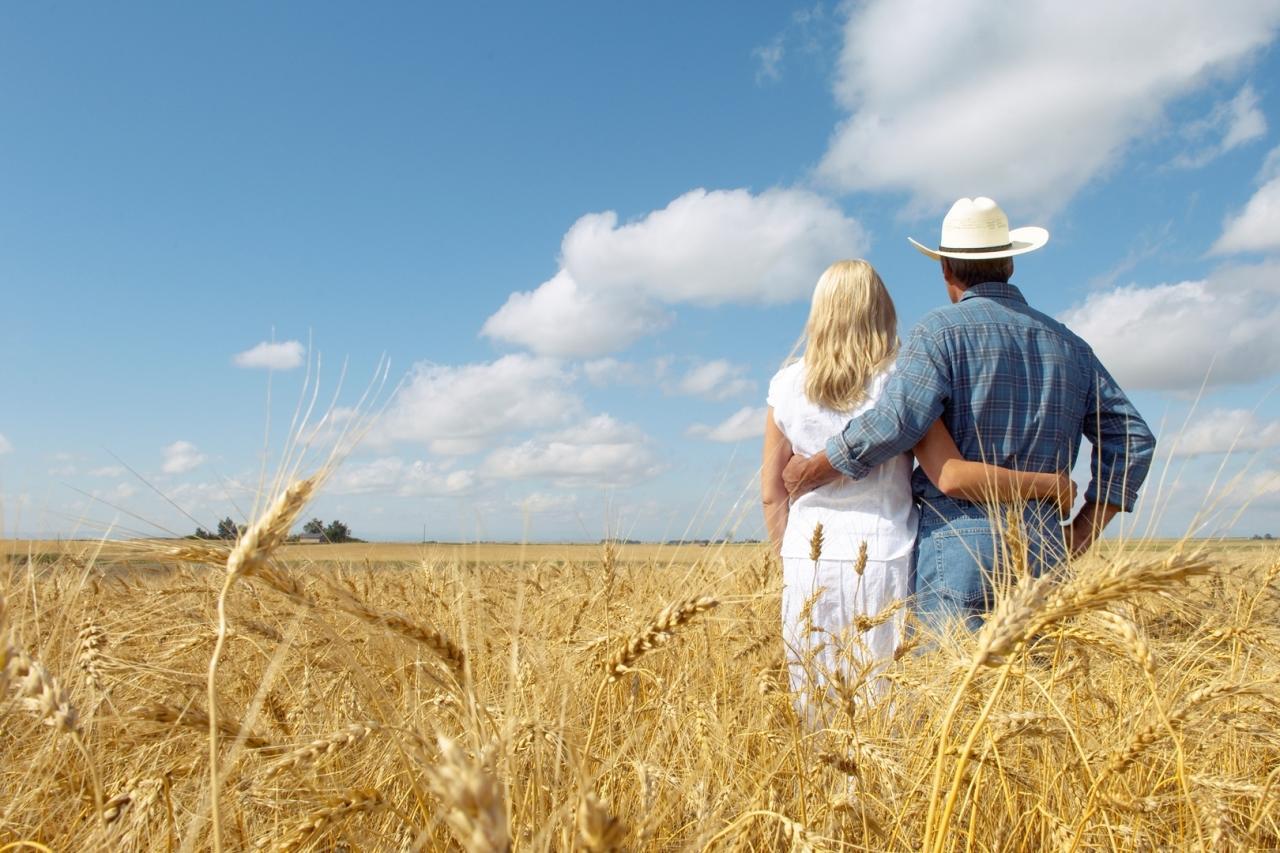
top-left (818, 0), bottom-right (1280, 213)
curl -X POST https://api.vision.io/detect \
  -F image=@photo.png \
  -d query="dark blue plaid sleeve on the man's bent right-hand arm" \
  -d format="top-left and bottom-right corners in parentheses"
top-left (1082, 353), bottom-right (1156, 512)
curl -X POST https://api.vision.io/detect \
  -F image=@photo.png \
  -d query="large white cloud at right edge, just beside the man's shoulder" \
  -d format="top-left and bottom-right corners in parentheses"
top-left (1060, 263), bottom-right (1280, 391)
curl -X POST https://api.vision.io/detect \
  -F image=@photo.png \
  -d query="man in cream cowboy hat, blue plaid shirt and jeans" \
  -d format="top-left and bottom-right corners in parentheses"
top-left (783, 199), bottom-right (1156, 628)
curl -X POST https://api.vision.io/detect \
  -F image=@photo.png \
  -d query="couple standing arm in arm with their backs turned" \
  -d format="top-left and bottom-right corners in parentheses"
top-left (760, 197), bottom-right (1156, 692)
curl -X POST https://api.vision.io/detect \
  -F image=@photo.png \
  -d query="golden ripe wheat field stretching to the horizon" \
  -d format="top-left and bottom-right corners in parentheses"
top-left (0, 502), bottom-right (1280, 850)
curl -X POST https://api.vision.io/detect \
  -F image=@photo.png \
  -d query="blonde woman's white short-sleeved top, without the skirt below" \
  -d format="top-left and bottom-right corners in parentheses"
top-left (768, 361), bottom-right (916, 560)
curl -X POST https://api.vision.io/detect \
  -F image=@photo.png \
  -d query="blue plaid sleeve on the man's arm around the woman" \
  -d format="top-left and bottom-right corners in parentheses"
top-left (827, 323), bottom-right (951, 480)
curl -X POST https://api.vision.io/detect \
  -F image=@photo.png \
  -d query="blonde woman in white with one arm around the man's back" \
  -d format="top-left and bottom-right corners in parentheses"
top-left (760, 260), bottom-right (1074, 704)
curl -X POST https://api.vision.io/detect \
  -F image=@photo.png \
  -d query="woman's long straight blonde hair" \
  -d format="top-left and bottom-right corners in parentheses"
top-left (804, 260), bottom-right (897, 411)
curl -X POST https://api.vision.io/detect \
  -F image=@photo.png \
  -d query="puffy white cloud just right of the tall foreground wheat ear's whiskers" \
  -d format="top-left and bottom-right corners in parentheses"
top-left (370, 355), bottom-right (582, 455)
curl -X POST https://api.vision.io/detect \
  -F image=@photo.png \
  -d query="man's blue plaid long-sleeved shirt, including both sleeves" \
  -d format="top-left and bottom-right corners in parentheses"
top-left (827, 282), bottom-right (1156, 524)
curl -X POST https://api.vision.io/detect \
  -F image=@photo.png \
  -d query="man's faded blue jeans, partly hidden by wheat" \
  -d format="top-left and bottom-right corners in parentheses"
top-left (913, 506), bottom-right (1065, 630)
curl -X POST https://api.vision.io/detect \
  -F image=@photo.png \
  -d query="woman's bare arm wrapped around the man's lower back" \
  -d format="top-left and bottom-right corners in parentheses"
top-left (915, 419), bottom-right (1075, 515)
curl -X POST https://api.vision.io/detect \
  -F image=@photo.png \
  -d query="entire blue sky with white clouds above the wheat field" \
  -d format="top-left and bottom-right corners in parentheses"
top-left (0, 0), bottom-right (1280, 539)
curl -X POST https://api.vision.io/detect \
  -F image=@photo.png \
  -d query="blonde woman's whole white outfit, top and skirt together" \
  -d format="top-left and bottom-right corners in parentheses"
top-left (768, 361), bottom-right (916, 719)
